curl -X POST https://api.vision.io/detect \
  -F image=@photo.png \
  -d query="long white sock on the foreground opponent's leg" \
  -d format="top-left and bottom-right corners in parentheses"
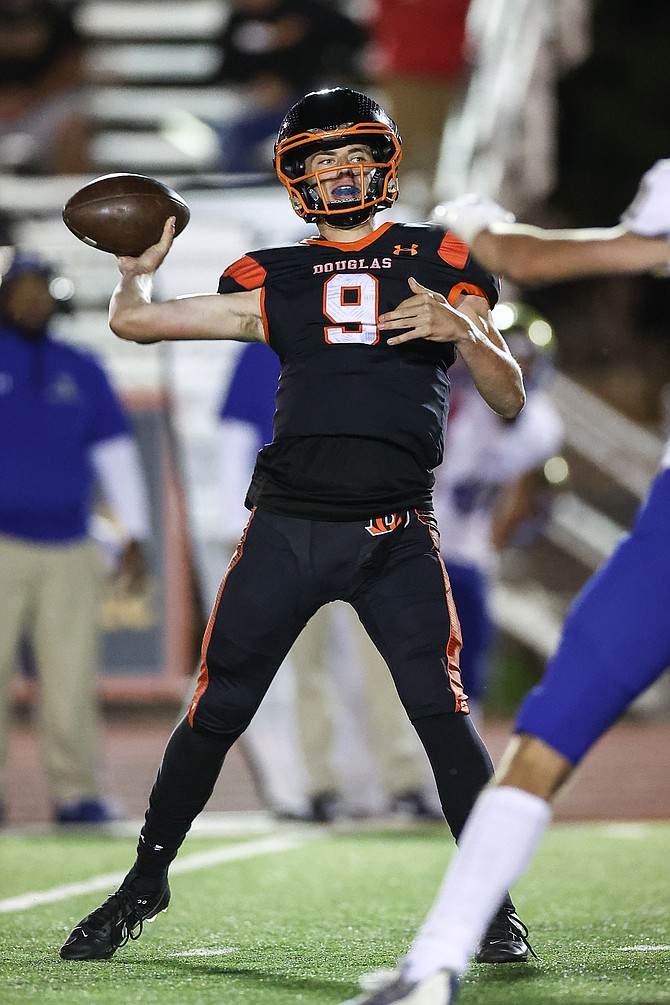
top-left (403, 786), bottom-right (551, 981)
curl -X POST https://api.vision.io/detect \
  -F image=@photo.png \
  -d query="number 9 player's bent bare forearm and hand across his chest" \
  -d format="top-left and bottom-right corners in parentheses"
top-left (379, 278), bottom-right (525, 419)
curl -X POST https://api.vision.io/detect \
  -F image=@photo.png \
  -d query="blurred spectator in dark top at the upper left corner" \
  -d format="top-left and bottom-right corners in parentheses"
top-left (0, 0), bottom-right (88, 174)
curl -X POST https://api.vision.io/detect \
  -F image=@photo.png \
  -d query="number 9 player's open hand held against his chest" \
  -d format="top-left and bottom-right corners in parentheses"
top-left (379, 278), bottom-right (480, 346)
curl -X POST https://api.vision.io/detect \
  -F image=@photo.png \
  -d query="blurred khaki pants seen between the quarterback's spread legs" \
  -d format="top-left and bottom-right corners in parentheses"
top-left (290, 604), bottom-right (425, 797)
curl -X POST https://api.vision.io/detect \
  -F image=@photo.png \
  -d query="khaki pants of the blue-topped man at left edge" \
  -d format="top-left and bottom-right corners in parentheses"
top-left (0, 536), bottom-right (103, 804)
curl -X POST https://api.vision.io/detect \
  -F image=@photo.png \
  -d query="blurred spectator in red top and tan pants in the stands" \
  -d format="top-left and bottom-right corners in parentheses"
top-left (370, 0), bottom-right (470, 212)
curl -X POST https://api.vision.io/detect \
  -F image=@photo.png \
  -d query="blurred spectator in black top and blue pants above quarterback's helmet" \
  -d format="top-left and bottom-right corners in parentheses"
top-left (211, 0), bottom-right (368, 173)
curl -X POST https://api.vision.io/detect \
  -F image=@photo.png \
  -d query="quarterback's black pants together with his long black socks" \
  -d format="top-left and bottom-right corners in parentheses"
top-left (139, 510), bottom-right (492, 871)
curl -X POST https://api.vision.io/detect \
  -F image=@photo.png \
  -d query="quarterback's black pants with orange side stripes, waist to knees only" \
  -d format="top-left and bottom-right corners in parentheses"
top-left (189, 510), bottom-right (464, 734)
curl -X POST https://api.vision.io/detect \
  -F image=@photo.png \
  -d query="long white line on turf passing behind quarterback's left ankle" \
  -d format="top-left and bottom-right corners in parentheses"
top-left (0, 832), bottom-right (320, 915)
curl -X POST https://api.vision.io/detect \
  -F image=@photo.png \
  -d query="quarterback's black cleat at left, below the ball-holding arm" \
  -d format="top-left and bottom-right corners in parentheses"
top-left (60, 866), bottom-right (170, 960)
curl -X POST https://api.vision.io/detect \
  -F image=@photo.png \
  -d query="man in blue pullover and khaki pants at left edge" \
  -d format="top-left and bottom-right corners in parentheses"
top-left (0, 252), bottom-right (149, 823)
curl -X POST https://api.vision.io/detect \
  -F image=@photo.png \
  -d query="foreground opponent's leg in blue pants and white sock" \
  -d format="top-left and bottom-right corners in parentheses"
top-left (349, 470), bottom-right (670, 1005)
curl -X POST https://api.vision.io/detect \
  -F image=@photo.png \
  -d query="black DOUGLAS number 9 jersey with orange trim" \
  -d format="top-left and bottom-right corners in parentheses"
top-left (219, 223), bottom-right (499, 519)
